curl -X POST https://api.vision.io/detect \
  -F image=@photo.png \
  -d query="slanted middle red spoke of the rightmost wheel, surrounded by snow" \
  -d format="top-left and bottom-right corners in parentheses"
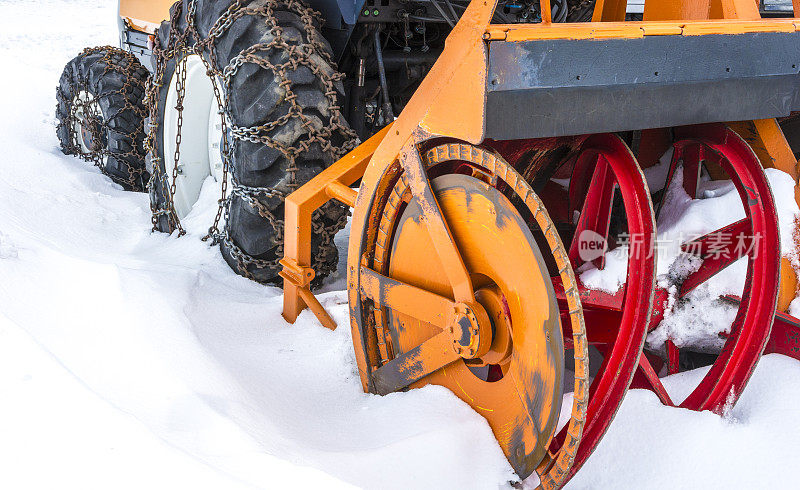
top-left (680, 218), bottom-right (757, 296)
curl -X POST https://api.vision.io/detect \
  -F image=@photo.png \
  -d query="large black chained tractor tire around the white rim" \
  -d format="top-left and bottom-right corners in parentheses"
top-left (151, 0), bottom-right (356, 285)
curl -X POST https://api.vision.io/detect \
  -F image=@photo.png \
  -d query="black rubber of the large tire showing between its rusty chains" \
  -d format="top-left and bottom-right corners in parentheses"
top-left (151, 0), bottom-right (354, 284)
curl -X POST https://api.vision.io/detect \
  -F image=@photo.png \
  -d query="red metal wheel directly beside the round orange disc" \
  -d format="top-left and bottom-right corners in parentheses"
top-left (545, 134), bottom-right (656, 473)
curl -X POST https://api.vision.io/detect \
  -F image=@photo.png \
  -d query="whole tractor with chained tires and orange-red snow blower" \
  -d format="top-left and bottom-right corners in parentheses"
top-left (57, 0), bottom-right (800, 489)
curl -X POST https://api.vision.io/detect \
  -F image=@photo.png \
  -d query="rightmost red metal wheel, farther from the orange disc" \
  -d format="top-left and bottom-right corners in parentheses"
top-left (632, 124), bottom-right (780, 412)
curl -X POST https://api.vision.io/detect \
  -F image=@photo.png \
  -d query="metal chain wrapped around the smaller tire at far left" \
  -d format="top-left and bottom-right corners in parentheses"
top-left (56, 46), bottom-right (149, 191)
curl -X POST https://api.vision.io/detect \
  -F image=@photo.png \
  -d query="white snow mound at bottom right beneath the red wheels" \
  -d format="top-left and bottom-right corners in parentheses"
top-left (568, 354), bottom-right (800, 489)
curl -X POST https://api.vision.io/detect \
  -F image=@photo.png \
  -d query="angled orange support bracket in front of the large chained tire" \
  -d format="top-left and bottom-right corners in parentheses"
top-left (279, 124), bottom-right (392, 330)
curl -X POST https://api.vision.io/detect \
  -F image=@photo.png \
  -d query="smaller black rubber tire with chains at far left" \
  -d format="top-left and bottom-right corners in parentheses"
top-left (56, 46), bottom-right (150, 191)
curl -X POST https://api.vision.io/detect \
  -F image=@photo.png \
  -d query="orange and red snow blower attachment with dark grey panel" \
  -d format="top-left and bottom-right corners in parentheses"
top-left (281, 0), bottom-right (800, 488)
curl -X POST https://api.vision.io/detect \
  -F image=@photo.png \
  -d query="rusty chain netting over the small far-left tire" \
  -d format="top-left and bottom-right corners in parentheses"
top-left (56, 46), bottom-right (148, 191)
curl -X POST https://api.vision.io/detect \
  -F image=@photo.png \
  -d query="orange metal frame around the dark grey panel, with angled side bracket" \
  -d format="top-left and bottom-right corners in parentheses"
top-left (281, 0), bottom-right (800, 330)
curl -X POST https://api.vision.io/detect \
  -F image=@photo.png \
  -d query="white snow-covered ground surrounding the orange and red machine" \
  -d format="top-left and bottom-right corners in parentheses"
top-left (0, 0), bottom-right (800, 489)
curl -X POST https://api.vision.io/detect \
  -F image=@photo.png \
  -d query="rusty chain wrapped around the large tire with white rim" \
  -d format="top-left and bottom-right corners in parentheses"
top-left (145, 0), bottom-right (358, 280)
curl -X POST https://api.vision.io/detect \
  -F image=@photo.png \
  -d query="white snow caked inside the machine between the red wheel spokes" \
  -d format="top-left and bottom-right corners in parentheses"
top-left (579, 145), bottom-right (800, 351)
